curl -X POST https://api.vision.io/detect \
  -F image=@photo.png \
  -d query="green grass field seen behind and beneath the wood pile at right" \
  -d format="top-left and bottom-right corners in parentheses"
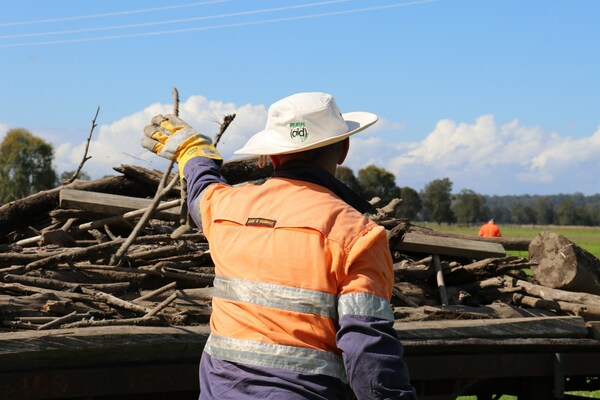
top-left (422, 223), bottom-right (600, 400)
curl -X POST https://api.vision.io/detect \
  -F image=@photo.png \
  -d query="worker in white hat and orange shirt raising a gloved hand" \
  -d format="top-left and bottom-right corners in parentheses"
top-left (142, 93), bottom-right (416, 400)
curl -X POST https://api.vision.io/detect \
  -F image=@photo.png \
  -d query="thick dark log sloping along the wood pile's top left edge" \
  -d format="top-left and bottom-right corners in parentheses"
top-left (0, 176), bottom-right (157, 237)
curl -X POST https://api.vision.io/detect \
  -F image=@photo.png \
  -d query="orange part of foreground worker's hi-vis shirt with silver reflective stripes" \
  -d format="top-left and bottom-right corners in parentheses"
top-left (200, 178), bottom-right (393, 380)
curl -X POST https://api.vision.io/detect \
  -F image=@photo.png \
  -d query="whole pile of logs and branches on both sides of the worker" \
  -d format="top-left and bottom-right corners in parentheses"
top-left (0, 158), bottom-right (600, 340)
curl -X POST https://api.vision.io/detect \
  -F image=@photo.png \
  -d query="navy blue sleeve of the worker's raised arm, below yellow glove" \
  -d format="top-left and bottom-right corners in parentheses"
top-left (183, 157), bottom-right (227, 228)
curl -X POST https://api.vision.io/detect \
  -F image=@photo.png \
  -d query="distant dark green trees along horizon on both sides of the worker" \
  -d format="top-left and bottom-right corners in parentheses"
top-left (0, 128), bottom-right (600, 226)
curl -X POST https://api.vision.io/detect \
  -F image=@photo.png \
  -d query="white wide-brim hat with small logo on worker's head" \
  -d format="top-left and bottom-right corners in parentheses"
top-left (235, 92), bottom-right (377, 155)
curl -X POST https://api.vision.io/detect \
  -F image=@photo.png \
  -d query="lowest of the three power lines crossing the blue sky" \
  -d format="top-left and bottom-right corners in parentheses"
top-left (0, 0), bottom-right (442, 48)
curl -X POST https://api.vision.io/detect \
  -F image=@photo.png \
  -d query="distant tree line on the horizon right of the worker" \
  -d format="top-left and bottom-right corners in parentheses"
top-left (336, 165), bottom-right (600, 226)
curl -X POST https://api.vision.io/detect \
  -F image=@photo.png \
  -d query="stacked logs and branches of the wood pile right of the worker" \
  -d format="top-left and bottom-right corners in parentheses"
top-left (390, 223), bottom-right (600, 330)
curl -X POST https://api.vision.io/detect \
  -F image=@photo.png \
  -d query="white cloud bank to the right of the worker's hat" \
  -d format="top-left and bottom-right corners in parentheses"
top-left (360, 115), bottom-right (600, 194)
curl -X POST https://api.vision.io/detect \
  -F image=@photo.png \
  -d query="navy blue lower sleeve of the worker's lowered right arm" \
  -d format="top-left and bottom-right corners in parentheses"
top-left (337, 315), bottom-right (417, 400)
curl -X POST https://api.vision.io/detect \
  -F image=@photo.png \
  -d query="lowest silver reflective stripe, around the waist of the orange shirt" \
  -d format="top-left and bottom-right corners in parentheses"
top-left (204, 334), bottom-right (347, 382)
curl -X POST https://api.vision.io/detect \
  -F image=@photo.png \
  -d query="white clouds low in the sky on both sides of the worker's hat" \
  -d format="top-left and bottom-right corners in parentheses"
top-left (5, 96), bottom-right (600, 194)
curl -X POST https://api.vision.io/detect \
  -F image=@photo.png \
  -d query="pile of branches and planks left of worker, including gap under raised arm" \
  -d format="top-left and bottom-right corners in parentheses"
top-left (0, 158), bottom-right (272, 331)
